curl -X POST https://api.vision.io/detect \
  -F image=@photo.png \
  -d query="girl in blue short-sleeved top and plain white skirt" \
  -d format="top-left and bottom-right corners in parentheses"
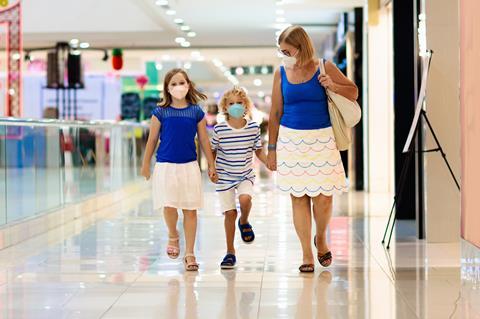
top-left (142, 69), bottom-right (216, 271)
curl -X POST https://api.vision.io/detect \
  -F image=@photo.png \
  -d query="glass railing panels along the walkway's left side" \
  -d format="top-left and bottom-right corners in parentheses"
top-left (0, 118), bottom-right (148, 226)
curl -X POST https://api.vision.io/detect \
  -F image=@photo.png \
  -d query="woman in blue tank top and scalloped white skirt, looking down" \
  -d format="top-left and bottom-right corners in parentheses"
top-left (268, 26), bottom-right (358, 272)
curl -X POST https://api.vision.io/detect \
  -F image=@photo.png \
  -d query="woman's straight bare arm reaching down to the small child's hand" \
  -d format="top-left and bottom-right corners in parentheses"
top-left (267, 69), bottom-right (283, 171)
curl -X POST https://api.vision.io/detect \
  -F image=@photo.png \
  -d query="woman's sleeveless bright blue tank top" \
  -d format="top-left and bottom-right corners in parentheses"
top-left (280, 66), bottom-right (332, 130)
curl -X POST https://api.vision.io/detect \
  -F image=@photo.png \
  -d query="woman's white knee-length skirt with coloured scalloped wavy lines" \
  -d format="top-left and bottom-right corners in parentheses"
top-left (277, 126), bottom-right (348, 197)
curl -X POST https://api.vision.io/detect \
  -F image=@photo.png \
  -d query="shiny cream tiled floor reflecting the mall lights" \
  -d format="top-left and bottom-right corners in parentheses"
top-left (0, 178), bottom-right (480, 319)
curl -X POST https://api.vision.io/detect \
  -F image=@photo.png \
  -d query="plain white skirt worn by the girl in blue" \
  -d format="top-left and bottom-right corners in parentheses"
top-left (152, 161), bottom-right (203, 210)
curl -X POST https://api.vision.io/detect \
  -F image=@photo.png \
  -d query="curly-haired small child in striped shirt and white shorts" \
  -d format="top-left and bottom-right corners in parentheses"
top-left (212, 87), bottom-right (266, 269)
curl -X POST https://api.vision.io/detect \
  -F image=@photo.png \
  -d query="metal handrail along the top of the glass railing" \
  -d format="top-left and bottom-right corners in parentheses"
top-left (0, 117), bottom-right (149, 128)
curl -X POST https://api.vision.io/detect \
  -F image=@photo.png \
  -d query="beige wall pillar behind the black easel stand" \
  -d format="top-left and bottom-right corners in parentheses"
top-left (425, 0), bottom-right (462, 242)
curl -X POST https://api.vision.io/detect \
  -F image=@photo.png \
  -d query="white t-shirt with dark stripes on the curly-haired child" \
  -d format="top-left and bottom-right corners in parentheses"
top-left (212, 121), bottom-right (262, 192)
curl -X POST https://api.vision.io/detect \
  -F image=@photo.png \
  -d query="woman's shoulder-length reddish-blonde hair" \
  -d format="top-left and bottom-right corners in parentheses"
top-left (277, 25), bottom-right (315, 65)
